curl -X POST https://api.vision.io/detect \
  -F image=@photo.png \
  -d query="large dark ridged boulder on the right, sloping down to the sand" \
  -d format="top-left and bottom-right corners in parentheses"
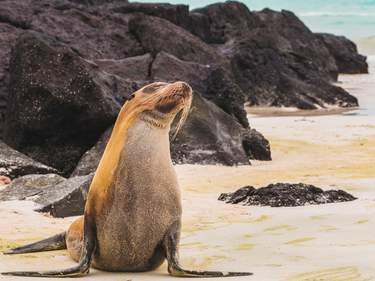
top-left (212, 4), bottom-right (358, 109)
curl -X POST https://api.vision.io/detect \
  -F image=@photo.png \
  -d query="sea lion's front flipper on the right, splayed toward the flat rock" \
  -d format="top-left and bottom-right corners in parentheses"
top-left (163, 222), bottom-right (252, 278)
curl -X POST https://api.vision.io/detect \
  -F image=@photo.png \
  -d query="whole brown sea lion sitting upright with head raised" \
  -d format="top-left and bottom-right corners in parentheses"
top-left (2, 82), bottom-right (251, 277)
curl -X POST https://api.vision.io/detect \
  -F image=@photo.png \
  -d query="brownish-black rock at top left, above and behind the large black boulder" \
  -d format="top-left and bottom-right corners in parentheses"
top-left (29, 0), bottom-right (145, 59)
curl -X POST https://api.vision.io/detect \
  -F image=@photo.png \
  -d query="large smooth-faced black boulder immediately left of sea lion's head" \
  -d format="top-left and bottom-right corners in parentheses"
top-left (4, 33), bottom-right (123, 174)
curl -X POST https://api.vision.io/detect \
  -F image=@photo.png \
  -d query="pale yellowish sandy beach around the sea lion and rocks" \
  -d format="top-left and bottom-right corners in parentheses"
top-left (0, 57), bottom-right (375, 281)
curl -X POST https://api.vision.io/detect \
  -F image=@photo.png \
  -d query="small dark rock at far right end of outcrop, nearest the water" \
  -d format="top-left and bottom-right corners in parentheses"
top-left (316, 33), bottom-right (368, 74)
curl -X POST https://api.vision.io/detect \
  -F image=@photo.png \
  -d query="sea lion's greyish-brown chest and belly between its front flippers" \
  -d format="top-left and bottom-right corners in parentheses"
top-left (94, 120), bottom-right (181, 271)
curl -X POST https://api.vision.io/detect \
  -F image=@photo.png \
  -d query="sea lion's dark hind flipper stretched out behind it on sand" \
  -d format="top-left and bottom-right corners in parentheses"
top-left (3, 232), bottom-right (66, 255)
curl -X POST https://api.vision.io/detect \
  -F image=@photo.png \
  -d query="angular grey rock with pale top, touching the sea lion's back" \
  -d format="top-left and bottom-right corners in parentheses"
top-left (34, 174), bottom-right (94, 218)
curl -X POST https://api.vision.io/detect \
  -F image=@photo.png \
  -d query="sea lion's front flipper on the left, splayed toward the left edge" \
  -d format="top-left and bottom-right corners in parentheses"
top-left (1, 215), bottom-right (96, 277)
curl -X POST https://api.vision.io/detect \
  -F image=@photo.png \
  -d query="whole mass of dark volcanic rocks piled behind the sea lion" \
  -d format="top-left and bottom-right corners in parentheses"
top-left (0, 0), bottom-right (363, 168)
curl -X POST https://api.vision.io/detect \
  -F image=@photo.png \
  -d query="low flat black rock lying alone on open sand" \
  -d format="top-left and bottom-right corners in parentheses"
top-left (219, 183), bottom-right (357, 207)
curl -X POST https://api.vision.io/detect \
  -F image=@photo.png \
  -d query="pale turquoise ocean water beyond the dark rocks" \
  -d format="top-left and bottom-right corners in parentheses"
top-left (138, 0), bottom-right (375, 40)
